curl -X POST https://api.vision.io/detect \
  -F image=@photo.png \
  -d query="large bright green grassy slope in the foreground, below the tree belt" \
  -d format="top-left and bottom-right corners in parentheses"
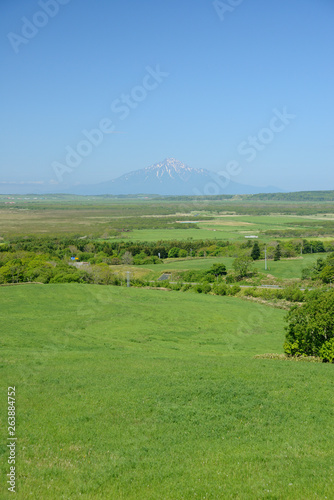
top-left (0, 285), bottom-right (334, 500)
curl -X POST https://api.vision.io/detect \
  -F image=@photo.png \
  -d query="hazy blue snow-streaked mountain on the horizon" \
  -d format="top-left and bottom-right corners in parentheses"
top-left (0, 158), bottom-right (283, 196)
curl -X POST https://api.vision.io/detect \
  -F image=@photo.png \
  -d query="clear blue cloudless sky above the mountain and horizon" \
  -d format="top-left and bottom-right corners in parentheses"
top-left (0, 0), bottom-right (334, 192)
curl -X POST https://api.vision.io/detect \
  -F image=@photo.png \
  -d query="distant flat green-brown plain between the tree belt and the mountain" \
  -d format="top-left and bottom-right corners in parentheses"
top-left (0, 193), bottom-right (334, 241)
